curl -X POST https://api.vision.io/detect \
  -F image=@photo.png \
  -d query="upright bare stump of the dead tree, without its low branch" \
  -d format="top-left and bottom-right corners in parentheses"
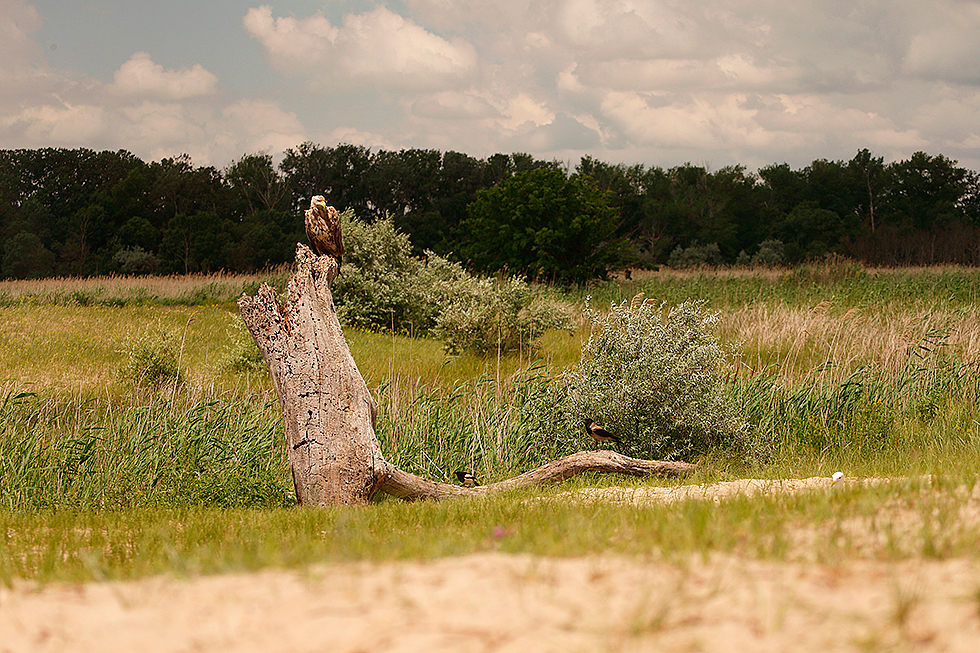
top-left (238, 245), bottom-right (384, 505)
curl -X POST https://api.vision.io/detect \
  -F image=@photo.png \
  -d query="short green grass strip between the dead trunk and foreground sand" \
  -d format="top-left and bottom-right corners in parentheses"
top-left (0, 472), bottom-right (978, 582)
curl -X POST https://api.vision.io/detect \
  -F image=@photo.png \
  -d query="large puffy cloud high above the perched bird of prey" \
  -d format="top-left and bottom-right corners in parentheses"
top-left (244, 5), bottom-right (478, 91)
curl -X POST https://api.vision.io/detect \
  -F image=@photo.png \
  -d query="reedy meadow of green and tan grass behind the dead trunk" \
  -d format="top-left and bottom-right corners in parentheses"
top-left (0, 264), bottom-right (980, 509)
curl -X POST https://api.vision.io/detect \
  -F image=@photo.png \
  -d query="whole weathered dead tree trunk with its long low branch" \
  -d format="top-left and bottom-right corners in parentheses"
top-left (238, 239), bottom-right (696, 506)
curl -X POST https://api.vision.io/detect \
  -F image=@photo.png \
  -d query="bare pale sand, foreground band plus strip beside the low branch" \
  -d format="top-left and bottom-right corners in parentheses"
top-left (0, 479), bottom-right (980, 653)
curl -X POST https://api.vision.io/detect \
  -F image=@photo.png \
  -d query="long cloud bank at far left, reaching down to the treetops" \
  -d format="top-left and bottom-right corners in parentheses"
top-left (0, 5), bottom-right (306, 166)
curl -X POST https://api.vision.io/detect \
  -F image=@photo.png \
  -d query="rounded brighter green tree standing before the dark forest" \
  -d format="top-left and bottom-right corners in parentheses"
top-left (459, 168), bottom-right (625, 283)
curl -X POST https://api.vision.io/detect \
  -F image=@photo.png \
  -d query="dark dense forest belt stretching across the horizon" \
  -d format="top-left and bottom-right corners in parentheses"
top-left (0, 143), bottom-right (980, 283)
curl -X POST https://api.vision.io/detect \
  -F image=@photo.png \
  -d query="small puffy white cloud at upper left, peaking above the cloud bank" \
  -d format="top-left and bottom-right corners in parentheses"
top-left (113, 52), bottom-right (218, 100)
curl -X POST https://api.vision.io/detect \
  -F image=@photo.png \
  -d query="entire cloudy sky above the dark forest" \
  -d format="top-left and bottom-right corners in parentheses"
top-left (0, 0), bottom-right (980, 170)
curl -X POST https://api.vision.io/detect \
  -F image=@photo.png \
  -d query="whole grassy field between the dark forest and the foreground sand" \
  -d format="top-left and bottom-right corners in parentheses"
top-left (0, 261), bottom-right (980, 580)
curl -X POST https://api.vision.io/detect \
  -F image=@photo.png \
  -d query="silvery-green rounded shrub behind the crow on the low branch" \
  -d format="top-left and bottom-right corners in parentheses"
top-left (565, 294), bottom-right (748, 460)
